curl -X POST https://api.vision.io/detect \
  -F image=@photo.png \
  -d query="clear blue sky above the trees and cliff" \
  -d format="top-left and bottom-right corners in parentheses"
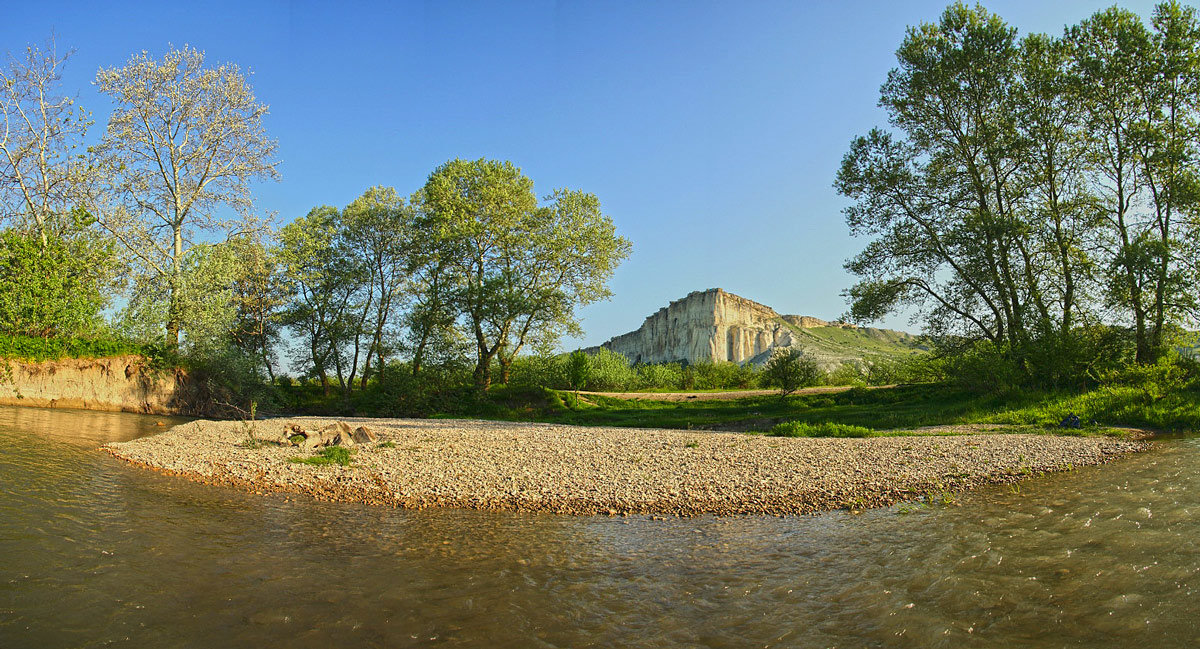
top-left (0, 0), bottom-right (1166, 348)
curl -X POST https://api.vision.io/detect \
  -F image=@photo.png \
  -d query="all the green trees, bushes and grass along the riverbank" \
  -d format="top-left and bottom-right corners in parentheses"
top-left (0, 2), bottom-right (1200, 431)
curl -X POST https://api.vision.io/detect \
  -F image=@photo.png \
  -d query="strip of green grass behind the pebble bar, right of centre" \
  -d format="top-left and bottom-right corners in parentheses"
top-left (445, 385), bottom-right (1200, 432)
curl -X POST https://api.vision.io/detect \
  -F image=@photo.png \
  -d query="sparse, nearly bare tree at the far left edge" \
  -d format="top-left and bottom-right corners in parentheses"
top-left (0, 40), bottom-right (95, 248)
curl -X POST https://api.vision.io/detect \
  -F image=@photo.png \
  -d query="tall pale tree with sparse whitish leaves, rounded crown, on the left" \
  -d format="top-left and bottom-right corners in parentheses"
top-left (90, 46), bottom-right (278, 347)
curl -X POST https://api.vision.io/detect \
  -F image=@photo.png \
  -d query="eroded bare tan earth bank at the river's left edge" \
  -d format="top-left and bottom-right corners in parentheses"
top-left (0, 356), bottom-right (193, 415)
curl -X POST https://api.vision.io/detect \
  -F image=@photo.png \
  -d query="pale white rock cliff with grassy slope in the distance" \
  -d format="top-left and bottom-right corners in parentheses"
top-left (592, 288), bottom-right (911, 367)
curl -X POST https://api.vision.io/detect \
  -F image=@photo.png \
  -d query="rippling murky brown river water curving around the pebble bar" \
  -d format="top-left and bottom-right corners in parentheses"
top-left (0, 408), bottom-right (1200, 649)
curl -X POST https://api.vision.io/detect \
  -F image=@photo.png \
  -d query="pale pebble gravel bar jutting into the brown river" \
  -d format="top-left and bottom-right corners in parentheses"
top-left (106, 417), bottom-right (1148, 516)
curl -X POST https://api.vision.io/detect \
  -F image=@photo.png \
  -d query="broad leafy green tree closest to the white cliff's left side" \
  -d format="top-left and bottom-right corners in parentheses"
top-left (419, 160), bottom-right (629, 390)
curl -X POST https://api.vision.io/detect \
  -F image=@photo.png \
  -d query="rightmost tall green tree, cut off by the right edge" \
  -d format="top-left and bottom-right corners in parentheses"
top-left (1067, 2), bottom-right (1200, 363)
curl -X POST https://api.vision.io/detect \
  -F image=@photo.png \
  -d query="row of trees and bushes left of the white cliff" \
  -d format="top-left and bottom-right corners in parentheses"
top-left (0, 42), bottom-right (630, 396)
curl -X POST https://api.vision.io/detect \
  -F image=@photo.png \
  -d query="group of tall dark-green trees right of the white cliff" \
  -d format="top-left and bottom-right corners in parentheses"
top-left (835, 1), bottom-right (1200, 383)
